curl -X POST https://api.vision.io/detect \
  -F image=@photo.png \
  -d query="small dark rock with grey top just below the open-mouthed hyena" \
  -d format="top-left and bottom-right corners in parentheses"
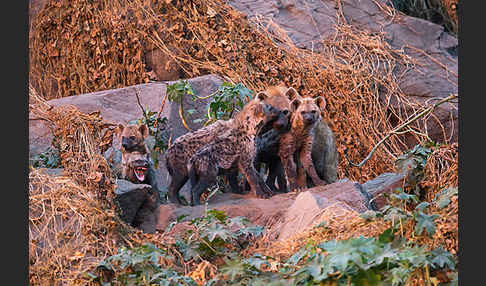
top-left (115, 179), bottom-right (157, 233)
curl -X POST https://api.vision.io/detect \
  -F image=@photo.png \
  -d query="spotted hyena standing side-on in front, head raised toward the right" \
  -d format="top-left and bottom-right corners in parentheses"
top-left (187, 92), bottom-right (281, 205)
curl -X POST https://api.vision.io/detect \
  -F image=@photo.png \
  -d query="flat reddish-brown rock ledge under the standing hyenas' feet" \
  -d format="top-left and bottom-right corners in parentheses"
top-left (156, 180), bottom-right (369, 239)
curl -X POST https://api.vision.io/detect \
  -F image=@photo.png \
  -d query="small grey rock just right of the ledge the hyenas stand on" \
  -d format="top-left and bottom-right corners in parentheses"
top-left (361, 173), bottom-right (405, 210)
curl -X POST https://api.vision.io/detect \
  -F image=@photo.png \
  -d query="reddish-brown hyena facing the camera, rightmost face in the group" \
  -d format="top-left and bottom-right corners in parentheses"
top-left (278, 96), bottom-right (327, 190)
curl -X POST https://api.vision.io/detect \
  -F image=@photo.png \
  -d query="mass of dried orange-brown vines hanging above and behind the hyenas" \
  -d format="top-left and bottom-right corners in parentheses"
top-left (30, 0), bottom-right (456, 182)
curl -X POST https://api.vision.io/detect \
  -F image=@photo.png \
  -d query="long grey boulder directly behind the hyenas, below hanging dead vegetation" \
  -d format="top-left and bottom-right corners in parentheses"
top-left (29, 75), bottom-right (223, 201)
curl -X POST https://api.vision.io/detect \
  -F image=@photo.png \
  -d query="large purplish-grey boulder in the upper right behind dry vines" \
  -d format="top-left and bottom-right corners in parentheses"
top-left (229, 0), bottom-right (459, 147)
